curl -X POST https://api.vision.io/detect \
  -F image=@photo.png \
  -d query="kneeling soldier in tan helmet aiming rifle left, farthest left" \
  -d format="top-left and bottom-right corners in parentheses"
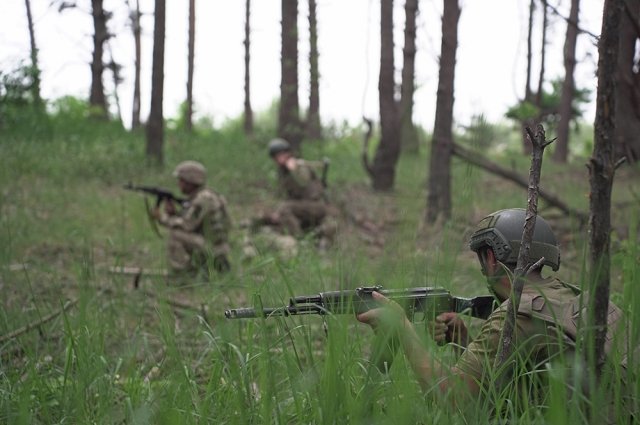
top-left (153, 161), bottom-right (231, 274)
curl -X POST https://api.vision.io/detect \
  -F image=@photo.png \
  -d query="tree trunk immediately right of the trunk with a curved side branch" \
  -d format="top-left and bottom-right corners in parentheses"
top-left (400, 0), bottom-right (419, 153)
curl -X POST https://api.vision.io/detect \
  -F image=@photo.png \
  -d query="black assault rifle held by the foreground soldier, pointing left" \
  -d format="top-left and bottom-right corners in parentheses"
top-left (224, 286), bottom-right (494, 321)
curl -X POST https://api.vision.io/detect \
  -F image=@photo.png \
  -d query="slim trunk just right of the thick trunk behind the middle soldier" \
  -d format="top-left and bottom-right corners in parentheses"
top-left (307, 0), bottom-right (322, 140)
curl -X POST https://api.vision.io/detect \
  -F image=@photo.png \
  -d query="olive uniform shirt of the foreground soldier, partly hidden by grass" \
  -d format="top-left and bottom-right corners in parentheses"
top-left (456, 278), bottom-right (627, 412)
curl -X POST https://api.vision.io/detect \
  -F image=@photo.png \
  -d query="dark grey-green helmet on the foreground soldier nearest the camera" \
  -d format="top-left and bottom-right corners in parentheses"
top-left (469, 208), bottom-right (560, 271)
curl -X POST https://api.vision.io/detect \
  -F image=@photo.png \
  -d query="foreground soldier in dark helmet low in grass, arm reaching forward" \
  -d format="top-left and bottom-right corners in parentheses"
top-left (357, 209), bottom-right (633, 422)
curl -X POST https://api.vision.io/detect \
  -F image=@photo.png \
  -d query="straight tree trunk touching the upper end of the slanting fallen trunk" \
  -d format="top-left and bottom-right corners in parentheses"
top-left (426, 0), bottom-right (460, 223)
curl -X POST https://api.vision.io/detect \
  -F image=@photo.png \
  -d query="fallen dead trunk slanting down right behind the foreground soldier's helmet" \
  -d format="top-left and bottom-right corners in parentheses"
top-left (452, 143), bottom-right (589, 226)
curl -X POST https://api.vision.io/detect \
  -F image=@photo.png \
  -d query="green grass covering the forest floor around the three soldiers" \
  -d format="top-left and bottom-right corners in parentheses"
top-left (0, 105), bottom-right (640, 424)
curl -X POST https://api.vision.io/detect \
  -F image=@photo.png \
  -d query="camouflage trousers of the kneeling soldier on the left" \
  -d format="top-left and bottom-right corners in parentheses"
top-left (167, 229), bottom-right (230, 272)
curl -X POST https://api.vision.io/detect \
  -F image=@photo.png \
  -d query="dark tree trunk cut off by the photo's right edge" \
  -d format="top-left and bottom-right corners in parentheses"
top-left (614, 1), bottom-right (640, 163)
